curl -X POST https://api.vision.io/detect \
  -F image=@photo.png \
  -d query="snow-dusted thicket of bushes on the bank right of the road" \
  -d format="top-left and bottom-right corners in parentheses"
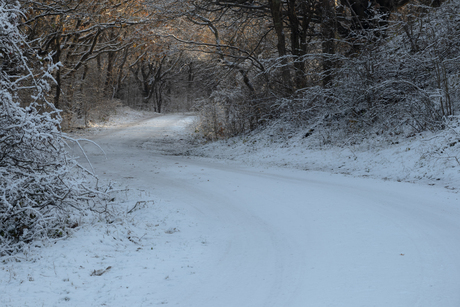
top-left (273, 0), bottom-right (460, 146)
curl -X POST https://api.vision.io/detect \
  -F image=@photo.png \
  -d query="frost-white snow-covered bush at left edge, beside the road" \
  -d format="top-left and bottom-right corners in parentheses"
top-left (0, 1), bottom-right (108, 257)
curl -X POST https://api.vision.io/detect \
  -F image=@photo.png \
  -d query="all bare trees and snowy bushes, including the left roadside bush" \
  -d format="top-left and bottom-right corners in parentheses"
top-left (0, 0), bottom-right (460, 254)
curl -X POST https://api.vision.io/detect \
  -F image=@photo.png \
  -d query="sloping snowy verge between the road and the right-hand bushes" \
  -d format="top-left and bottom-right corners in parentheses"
top-left (191, 119), bottom-right (460, 190)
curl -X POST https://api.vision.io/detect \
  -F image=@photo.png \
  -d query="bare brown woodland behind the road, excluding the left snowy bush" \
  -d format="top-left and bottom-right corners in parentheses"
top-left (9, 0), bottom-right (459, 134)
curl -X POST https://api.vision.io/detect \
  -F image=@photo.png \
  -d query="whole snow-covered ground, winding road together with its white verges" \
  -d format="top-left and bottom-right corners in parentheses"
top-left (0, 109), bottom-right (460, 307)
